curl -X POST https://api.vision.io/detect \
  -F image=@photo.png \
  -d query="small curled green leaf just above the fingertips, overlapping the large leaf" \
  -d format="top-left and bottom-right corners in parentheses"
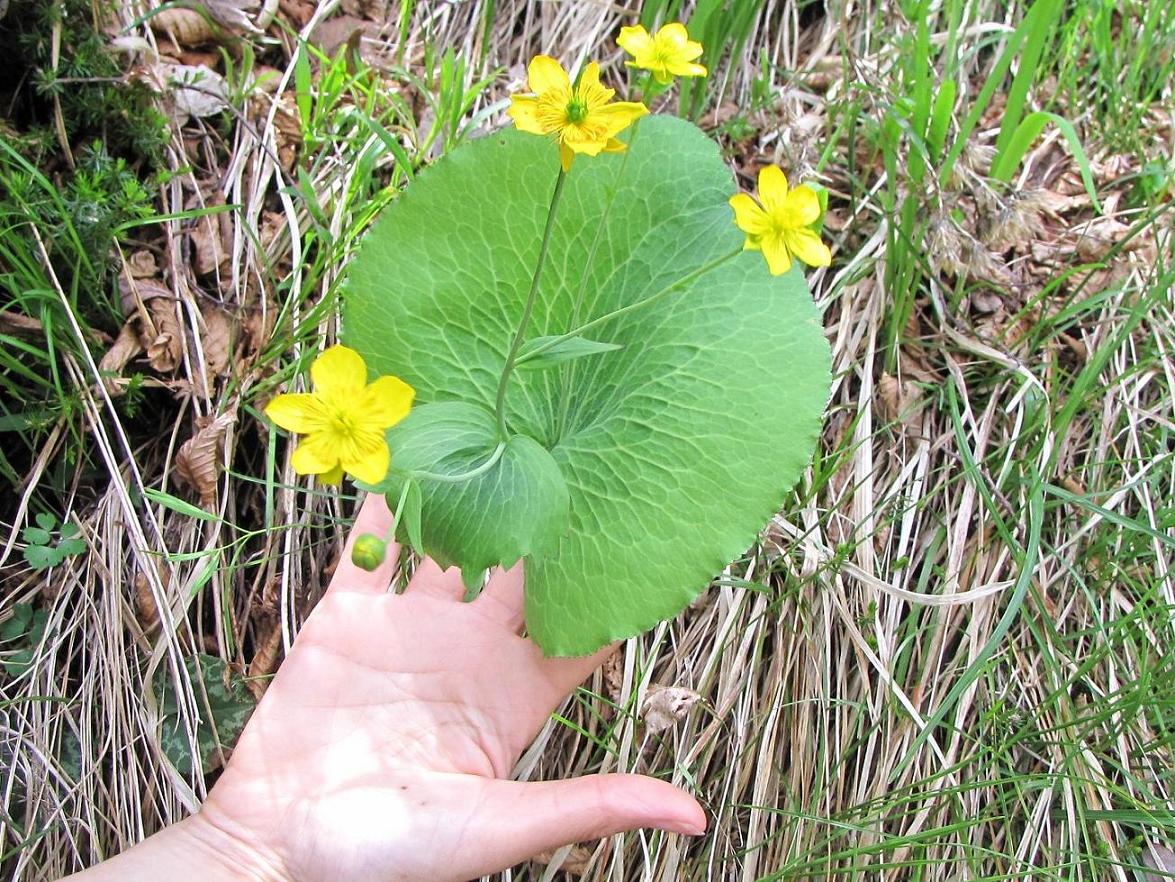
top-left (387, 402), bottom-right (569, 577)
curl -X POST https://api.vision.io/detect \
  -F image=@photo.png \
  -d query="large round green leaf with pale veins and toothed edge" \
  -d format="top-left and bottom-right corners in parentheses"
top-left (344, 117), bottom-right (828, 654)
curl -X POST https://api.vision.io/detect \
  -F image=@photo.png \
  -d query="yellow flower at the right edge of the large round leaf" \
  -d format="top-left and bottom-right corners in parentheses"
top-left (731, 166), bottom-right (832, 276)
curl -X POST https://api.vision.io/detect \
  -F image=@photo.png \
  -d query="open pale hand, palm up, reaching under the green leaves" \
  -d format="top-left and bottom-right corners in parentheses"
top-left (69, 496), bottom-right (706, 882)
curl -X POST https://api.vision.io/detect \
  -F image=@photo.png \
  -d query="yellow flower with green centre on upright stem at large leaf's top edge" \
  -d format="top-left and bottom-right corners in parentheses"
top-left (506, 55), bottom-right (649, 171)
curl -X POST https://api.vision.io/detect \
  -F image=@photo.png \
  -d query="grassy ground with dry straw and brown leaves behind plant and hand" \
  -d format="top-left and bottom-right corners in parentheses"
top-left (0, 0), bottom-right (1175, 882)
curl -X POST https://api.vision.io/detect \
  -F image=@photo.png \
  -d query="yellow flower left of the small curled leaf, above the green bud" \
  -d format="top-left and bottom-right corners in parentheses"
top-left (266, 346), bottom-right (416, 484)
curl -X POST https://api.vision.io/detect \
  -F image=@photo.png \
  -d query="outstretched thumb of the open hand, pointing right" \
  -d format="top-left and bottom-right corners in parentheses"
top-left (477, 775), bottom-right (706, 866)
